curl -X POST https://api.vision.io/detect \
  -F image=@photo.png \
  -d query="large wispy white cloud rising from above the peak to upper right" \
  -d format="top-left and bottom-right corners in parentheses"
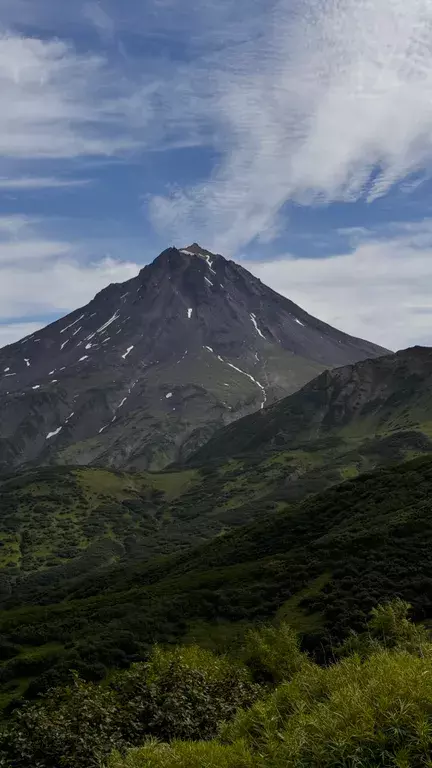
top-left (150, 0), bottom-right (432, 253)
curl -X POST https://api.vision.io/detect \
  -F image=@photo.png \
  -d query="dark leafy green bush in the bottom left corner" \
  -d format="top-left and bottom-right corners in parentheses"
top-left (0, 647), bottom-right (258, 768)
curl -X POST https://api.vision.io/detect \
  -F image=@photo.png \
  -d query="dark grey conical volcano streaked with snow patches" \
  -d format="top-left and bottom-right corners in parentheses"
top-left (0, 244), bottom-right (385, 469)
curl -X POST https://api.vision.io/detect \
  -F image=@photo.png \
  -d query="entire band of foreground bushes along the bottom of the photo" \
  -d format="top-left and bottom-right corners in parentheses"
top-left (0, 601), bottom-right (432, 768)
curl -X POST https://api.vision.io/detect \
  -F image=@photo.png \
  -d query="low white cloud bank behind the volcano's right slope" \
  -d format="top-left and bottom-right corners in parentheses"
top-left (243, 221), bottom-right (432, 349)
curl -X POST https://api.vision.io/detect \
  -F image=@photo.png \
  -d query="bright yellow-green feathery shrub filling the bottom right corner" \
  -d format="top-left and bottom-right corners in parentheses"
top-left (230, 650), bottom-right (432, 768)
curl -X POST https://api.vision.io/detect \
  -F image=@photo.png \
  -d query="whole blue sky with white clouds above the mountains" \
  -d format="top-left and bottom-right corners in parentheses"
top-left (0, 0), bottom-right (432, 349)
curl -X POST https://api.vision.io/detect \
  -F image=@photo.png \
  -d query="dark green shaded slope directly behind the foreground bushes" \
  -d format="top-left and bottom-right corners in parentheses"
top-left (0, 458), bottom-right (432, 708)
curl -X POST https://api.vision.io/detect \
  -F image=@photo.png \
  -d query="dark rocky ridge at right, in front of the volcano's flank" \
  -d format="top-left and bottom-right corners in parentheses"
top-left (190, 347), bottom-right (432, 469)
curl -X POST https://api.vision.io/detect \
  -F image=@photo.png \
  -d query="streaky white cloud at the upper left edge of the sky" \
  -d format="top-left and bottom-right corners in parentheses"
top-left (0, 34), bottom-right (140, 159)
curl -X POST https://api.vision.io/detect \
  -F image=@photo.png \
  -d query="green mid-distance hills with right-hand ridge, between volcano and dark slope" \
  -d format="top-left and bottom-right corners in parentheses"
top-left (0, 348), bottom-right (432, 601)
